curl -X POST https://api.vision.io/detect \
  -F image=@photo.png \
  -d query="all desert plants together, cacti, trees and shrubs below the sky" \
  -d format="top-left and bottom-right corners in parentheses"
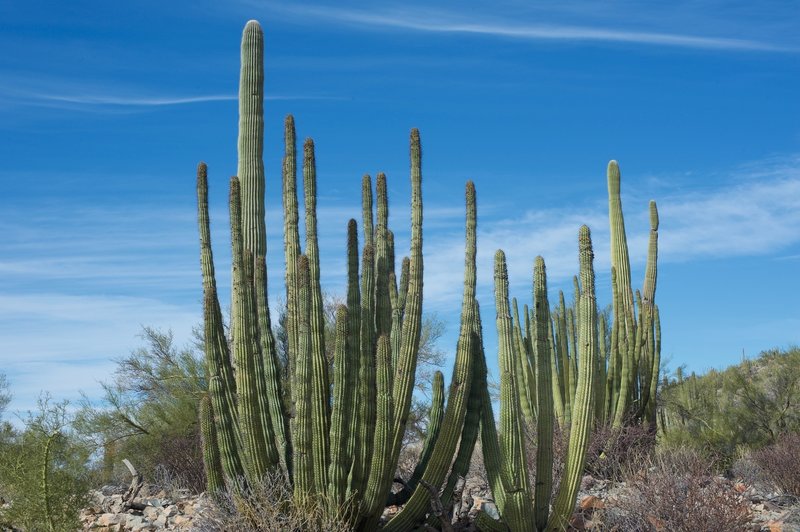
top-left (0, 16), bottom-right (800, 531)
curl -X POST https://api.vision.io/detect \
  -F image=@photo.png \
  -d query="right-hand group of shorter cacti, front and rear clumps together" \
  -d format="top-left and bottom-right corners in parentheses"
top-left (478, 165), bottom-right (661, 532)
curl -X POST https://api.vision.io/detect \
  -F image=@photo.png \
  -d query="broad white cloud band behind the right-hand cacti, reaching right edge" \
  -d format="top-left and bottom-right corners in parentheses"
top-left (412, 157), bottom-right (800, 309)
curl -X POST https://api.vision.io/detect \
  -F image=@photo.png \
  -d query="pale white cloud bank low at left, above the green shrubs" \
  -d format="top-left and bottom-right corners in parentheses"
top-left (0, 292), bottom-right (201, 416)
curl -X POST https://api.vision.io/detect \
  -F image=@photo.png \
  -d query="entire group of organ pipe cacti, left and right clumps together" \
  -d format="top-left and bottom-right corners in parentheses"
top-left (197, 21), bottom-right (659, 531)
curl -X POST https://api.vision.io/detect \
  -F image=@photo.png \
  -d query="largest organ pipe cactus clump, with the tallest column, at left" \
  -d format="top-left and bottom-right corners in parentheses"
top-left (197, 21), bottom-right (480, 530)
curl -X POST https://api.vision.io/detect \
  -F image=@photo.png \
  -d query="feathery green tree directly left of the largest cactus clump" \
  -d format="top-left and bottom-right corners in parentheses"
top-left (78, 327), bottom-right (206, 491)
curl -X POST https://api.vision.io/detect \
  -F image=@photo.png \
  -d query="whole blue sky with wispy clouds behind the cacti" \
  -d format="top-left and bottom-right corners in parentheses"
top-left (0, 0), bottom-right (800, 416)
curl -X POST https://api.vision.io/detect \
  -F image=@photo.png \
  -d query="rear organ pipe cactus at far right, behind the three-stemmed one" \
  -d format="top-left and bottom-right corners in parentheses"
top-left (544, 161), bottom-right (660, 430)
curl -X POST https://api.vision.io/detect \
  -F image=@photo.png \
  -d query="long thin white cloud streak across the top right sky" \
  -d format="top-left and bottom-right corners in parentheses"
top-left (250, 2), bottom-right (798, 52)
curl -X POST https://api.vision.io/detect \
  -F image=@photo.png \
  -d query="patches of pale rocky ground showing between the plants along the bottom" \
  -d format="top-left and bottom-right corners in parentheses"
top-left (76, 476), bottom-right (800, 532)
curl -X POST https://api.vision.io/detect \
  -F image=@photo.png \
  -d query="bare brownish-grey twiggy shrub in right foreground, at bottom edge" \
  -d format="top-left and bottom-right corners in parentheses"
top-left (601, 448), bottom-right (751, 532)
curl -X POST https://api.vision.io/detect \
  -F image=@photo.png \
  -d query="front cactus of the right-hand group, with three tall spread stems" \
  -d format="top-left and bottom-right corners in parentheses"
top-left (478, 226), bottom-right (598, 532)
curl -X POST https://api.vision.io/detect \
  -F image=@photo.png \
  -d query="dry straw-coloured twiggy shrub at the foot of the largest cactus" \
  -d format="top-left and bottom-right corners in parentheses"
top-left (195, 472), bottom-right (351, 532)
